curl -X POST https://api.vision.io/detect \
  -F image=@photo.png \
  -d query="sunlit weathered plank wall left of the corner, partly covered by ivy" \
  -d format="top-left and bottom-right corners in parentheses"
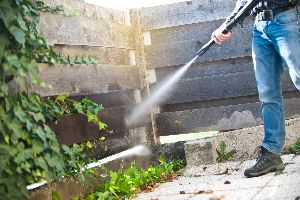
top-left (35, 0), bottom-right (147, 158)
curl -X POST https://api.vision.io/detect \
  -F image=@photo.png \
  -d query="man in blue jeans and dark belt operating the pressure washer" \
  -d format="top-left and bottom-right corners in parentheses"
top-left (212, 0), bottom-right (300, 177)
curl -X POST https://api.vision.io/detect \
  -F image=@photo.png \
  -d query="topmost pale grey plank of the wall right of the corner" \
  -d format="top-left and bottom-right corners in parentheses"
top-left (141, 0), bottom-right (236, 30)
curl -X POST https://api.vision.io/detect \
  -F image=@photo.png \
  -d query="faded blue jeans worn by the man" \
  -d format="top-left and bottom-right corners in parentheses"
top-left (252, 6), bottom-right (300, 154)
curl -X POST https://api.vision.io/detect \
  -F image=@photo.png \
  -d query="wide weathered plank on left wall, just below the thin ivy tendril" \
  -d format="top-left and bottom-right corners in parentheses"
top-left (34, 64), bottom-right (140, 96)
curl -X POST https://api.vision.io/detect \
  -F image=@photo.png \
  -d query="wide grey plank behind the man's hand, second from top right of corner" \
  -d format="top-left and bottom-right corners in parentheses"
top-left (145, 20), bottom-right (252, 68)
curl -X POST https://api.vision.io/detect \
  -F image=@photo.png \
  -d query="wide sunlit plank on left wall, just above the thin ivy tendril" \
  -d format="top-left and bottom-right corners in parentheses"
top-left (39, 13), bottom-right (134, 49)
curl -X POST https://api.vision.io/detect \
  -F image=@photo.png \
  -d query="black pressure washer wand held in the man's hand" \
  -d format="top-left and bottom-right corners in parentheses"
top-left (197, 0), bottom-right (259, 56)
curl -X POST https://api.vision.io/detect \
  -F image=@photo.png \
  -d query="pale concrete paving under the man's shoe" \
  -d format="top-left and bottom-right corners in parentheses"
top-left (135, 155), bottom-right (300, 200)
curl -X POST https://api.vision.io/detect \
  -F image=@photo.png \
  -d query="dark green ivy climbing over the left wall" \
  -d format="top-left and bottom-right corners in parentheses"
top-left (0, 0), bottom-right (106, 200)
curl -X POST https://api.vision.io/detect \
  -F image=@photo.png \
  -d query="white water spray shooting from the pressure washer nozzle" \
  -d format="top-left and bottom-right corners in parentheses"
top-left (126, 55), bottom-right (198, 126)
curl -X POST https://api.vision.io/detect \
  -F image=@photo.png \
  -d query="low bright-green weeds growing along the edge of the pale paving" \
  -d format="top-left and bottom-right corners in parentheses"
top-left (81, 156), bottom-right (183, 200)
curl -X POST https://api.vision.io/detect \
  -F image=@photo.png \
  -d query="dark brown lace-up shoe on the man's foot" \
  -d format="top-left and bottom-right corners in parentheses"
top-left (244, 147), bottom-right (285, 178)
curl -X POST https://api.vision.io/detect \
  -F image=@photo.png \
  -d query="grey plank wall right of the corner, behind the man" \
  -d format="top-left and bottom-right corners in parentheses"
top-left (140, 0), bottom-right (300, 137)
